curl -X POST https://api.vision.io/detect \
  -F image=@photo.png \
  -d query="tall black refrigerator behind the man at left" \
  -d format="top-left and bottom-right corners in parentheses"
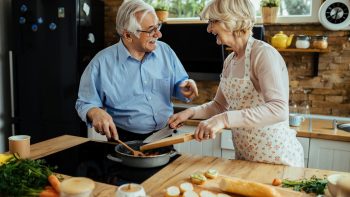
top-left (10, 0), bottom-right (104, 143)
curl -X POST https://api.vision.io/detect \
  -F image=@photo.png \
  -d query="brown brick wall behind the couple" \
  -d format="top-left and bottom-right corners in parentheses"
top-left (105, 0), bottom-right (350, 116)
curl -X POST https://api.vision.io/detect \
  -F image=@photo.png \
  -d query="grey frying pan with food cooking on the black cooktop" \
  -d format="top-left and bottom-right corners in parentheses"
top-left (107, 140), bottom-right (177, 168)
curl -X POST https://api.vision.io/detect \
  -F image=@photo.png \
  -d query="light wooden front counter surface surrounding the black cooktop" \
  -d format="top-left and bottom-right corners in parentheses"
top-left (31, 135), bottom-right (350, 196)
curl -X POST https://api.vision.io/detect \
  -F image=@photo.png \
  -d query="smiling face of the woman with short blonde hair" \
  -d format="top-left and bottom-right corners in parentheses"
top-left (207, 19), bottom-right (233, 45)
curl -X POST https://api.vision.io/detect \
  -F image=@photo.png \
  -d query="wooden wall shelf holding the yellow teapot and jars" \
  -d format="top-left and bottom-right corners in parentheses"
top-left (225, 47), bottom-right (330, 77)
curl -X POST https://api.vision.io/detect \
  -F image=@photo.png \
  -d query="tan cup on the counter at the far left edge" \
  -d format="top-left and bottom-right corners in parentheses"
top-left (9, 135), bottom-right (30, 159)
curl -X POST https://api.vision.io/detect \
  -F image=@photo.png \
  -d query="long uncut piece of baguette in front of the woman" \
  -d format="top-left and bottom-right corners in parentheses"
top-left (220, 178), bottom-right (281, 197)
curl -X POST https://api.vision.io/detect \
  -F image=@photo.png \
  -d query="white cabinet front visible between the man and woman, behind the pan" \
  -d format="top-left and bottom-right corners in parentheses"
top-left (174, 125), bottom-right (221, 157)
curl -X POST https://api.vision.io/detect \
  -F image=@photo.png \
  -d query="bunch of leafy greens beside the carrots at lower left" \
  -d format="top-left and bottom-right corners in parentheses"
top-left (0, 157), bottom-right (55, 196)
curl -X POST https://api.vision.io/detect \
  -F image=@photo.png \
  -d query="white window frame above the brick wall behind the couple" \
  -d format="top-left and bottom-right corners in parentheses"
top-left (167, 0), bottom-right (323, 24)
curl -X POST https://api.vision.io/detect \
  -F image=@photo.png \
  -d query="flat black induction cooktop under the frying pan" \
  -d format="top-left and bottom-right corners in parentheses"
top-left (41, 141), bottom-right (180, 186)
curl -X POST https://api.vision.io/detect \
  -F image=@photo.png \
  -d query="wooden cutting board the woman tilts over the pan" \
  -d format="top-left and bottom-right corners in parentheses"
top-left (140, 133), bottom-right (194, 151)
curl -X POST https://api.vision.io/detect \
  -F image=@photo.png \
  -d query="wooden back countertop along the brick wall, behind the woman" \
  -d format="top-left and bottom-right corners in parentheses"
top-left (185, 120), bottom-right (350, 142)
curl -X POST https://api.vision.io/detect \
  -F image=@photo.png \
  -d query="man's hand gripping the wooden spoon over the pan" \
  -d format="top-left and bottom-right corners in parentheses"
top-left (87, 107), bottom-right (119, 139)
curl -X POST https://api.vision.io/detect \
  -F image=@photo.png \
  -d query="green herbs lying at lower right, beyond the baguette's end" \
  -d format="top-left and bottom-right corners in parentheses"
top-left (282, 176), bottom-right (328, 194)
